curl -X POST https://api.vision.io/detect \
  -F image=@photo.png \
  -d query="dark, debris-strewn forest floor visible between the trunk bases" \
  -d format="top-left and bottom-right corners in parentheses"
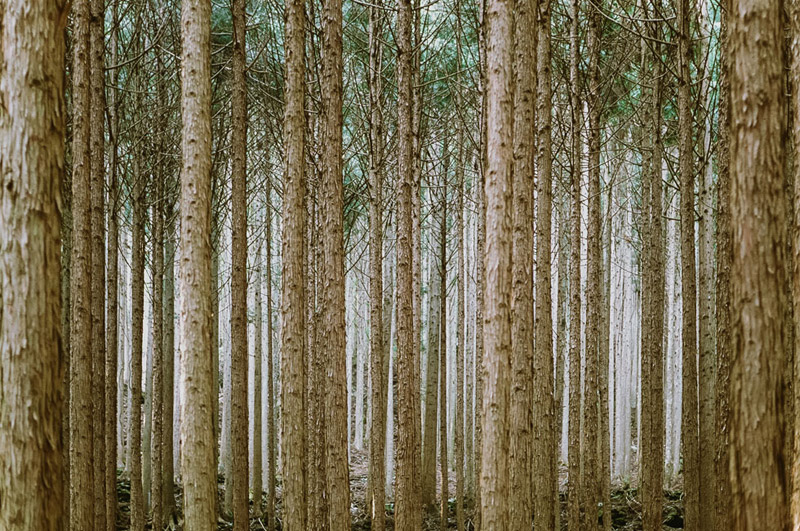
top-left (117, 452), bottom-right (683, 531)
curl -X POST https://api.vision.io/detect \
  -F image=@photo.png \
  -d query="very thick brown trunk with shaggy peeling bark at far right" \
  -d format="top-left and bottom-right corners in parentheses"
top-left (730, 0), bottom-right (790, 531)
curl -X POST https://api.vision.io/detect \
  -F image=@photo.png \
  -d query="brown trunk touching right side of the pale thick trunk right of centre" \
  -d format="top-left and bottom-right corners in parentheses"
top-left (508, 0), bottom-right (537, 520)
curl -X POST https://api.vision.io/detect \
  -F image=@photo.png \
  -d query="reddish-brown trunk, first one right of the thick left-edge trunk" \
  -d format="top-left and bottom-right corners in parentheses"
top-left (69, 0), bottom-right (95, 529)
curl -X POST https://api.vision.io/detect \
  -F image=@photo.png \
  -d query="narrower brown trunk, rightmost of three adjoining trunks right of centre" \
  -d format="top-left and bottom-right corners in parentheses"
top-left (532, 0), bottom-right (561, 531)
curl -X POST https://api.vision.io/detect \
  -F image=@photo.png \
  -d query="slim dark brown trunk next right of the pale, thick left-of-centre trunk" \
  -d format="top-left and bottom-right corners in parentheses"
top-left (231, 0), bottom-right (250, 531)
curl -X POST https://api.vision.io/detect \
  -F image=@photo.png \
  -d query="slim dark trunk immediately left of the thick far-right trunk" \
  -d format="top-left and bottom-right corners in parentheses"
top-left (714, 0), bottom-right (732, 531)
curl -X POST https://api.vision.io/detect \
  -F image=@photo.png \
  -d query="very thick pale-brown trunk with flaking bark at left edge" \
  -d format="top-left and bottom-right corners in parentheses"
top-left (0, 0), bottom-right (66, 531)
